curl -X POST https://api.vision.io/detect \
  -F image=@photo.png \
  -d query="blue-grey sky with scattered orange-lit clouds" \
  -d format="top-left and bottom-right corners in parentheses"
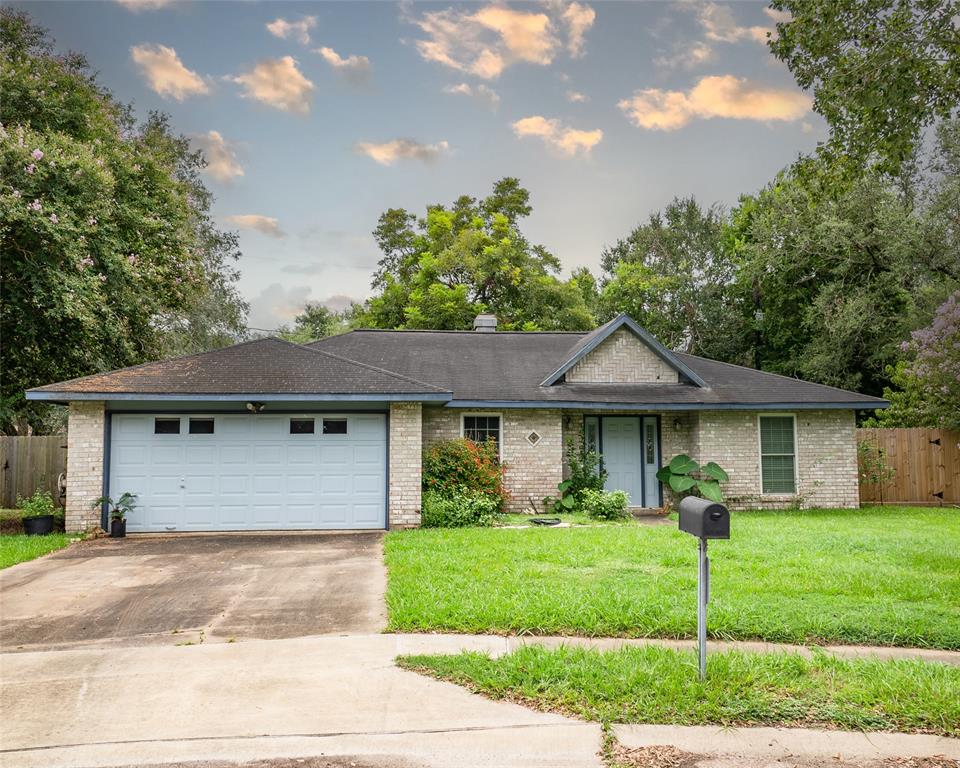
top-left (23, 0), bottom-right (824, 329)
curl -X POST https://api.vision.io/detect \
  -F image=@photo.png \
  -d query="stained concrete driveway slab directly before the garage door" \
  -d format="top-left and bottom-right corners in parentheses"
top-left (0, 533), bottom-right (386, 653)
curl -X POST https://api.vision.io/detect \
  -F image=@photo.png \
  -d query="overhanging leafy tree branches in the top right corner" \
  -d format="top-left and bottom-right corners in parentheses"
top-left (769, 0), bottom-right (960, 172)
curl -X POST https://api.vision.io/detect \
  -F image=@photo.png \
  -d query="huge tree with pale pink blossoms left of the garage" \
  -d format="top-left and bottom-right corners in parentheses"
top-left (0, 9), bottom-right (246, 431)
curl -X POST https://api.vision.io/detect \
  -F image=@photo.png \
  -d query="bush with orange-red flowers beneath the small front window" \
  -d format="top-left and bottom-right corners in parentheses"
top-left (423, 438), bottom-right (508, 512)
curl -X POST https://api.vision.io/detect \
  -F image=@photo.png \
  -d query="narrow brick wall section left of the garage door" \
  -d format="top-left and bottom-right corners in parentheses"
top-left (65, 402), bottom-right (105, 533)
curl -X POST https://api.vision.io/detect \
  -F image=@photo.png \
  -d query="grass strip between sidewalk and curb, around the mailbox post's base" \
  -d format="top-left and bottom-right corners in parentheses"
top-left (398, 646), bottom-right (960, 736)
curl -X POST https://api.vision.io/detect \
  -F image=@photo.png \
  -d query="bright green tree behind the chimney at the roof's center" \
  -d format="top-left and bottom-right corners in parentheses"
top-left (352, 178), bottom-right (594, 330)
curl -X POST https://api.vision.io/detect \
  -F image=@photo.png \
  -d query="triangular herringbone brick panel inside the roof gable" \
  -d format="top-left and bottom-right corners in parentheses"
top-left (567, 328), bottom-right (678, 384)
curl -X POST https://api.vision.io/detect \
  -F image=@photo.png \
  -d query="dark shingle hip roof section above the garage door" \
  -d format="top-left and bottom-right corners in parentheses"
top-left (30, 338), bottom-right (444, 395)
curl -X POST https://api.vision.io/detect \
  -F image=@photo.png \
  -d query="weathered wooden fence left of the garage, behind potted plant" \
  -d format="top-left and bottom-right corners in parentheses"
top-left (0, 435), bottom-right (67, 509)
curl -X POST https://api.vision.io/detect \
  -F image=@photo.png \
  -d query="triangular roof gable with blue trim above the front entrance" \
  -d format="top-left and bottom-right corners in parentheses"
top-left (541, 314), bottom-right (707, 387)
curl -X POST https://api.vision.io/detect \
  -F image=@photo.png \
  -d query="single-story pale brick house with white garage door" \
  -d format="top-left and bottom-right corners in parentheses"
top-left (27, 315), bottom-right (887, 531)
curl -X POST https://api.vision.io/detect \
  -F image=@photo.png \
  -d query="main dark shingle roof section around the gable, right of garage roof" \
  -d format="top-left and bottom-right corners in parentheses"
top-left (310, 331), bottom-right (886, 408)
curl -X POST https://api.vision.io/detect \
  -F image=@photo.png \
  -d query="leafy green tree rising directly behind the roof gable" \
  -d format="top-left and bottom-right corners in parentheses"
top-left (599, 197), bottom-right (744, 362)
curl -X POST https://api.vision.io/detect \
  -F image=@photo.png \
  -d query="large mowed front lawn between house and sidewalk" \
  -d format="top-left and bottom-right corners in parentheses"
top-left (385, 507), bottom-right (960, 649)
